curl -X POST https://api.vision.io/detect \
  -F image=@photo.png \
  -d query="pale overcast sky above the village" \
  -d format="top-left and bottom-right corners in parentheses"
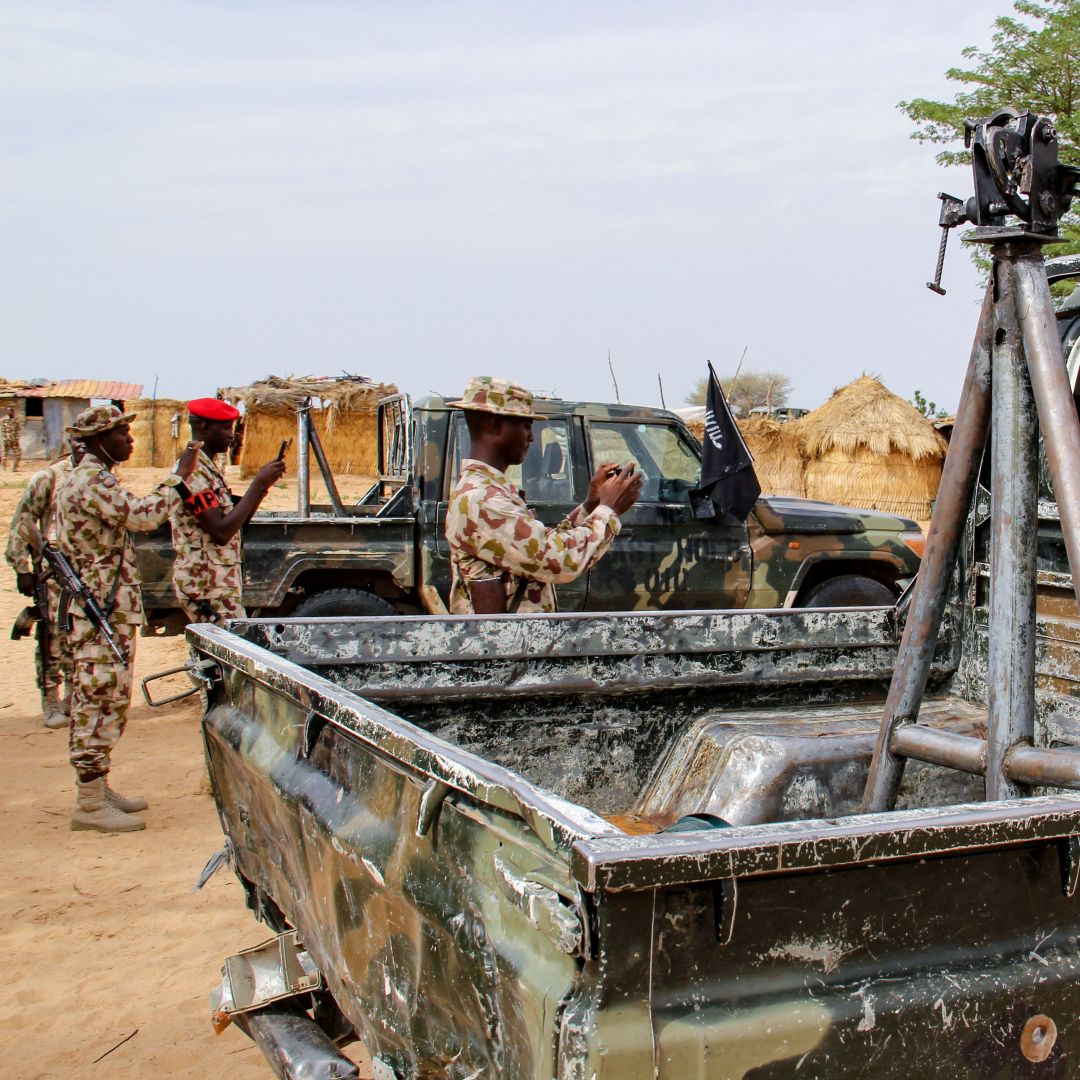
top-left (0, 0), bottom-right (1009, 409)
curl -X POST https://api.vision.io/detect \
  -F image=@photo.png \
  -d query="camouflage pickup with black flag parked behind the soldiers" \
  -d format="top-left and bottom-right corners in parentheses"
top-left (135, 397), bottom-right (923, 620)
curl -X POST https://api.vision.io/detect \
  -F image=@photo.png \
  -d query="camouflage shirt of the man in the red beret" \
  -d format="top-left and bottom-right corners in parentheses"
top-left (168, 451), bottom-right (243, 603)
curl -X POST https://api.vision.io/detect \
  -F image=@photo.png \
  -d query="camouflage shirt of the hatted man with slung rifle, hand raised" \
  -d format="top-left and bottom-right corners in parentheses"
top-left (56, 456), bottom-right (180, 625)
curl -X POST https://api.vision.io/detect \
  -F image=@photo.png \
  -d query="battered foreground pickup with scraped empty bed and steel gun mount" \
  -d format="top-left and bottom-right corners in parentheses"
top-left (172, 111), bottom-right (1080, 1080)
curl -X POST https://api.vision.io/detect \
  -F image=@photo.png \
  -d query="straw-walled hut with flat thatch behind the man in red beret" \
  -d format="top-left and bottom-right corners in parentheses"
top-left (218, 375), bottom-right (397, 476)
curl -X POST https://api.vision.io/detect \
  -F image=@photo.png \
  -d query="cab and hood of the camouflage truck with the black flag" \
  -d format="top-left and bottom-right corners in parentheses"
top-left (415, 396), bottom-right (922, 611)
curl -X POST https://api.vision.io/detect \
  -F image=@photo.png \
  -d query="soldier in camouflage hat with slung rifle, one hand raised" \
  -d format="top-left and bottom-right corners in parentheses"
top-left (56, 405), bottom-right (199, 833)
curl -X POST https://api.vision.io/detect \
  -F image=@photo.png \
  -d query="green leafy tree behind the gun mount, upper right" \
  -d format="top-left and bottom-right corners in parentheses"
top-left (899, 0), bottom-right (1080, 260)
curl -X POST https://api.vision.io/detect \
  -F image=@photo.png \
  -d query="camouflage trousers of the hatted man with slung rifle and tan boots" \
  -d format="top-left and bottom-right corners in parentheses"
top-left (69, 616), bottom-right (138, 783)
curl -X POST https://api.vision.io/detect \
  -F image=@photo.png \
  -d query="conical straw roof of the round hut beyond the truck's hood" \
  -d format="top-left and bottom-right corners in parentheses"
top-left (797, 375), bottom-right (947, 461)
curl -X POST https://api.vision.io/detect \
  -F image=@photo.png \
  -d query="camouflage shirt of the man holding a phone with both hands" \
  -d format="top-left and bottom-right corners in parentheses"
top-left (446, 458), bottom-right (620, 615)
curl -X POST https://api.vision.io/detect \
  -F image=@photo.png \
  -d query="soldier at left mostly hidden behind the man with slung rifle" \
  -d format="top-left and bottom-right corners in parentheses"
top-left (4, 438), bottom-right (83, 728)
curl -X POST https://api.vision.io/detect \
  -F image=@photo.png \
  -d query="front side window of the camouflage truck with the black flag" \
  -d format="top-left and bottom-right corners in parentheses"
top-left (589, 421), bottom-right (701, 502)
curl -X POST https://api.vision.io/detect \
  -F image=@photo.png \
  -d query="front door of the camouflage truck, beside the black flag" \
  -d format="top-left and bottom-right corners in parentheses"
top-left (585, 420), bottom-right (751, 611)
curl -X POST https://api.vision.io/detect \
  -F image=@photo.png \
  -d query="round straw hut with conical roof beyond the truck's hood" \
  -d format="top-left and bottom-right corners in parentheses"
top-left (795, 375), bottom-right (946, 521)
